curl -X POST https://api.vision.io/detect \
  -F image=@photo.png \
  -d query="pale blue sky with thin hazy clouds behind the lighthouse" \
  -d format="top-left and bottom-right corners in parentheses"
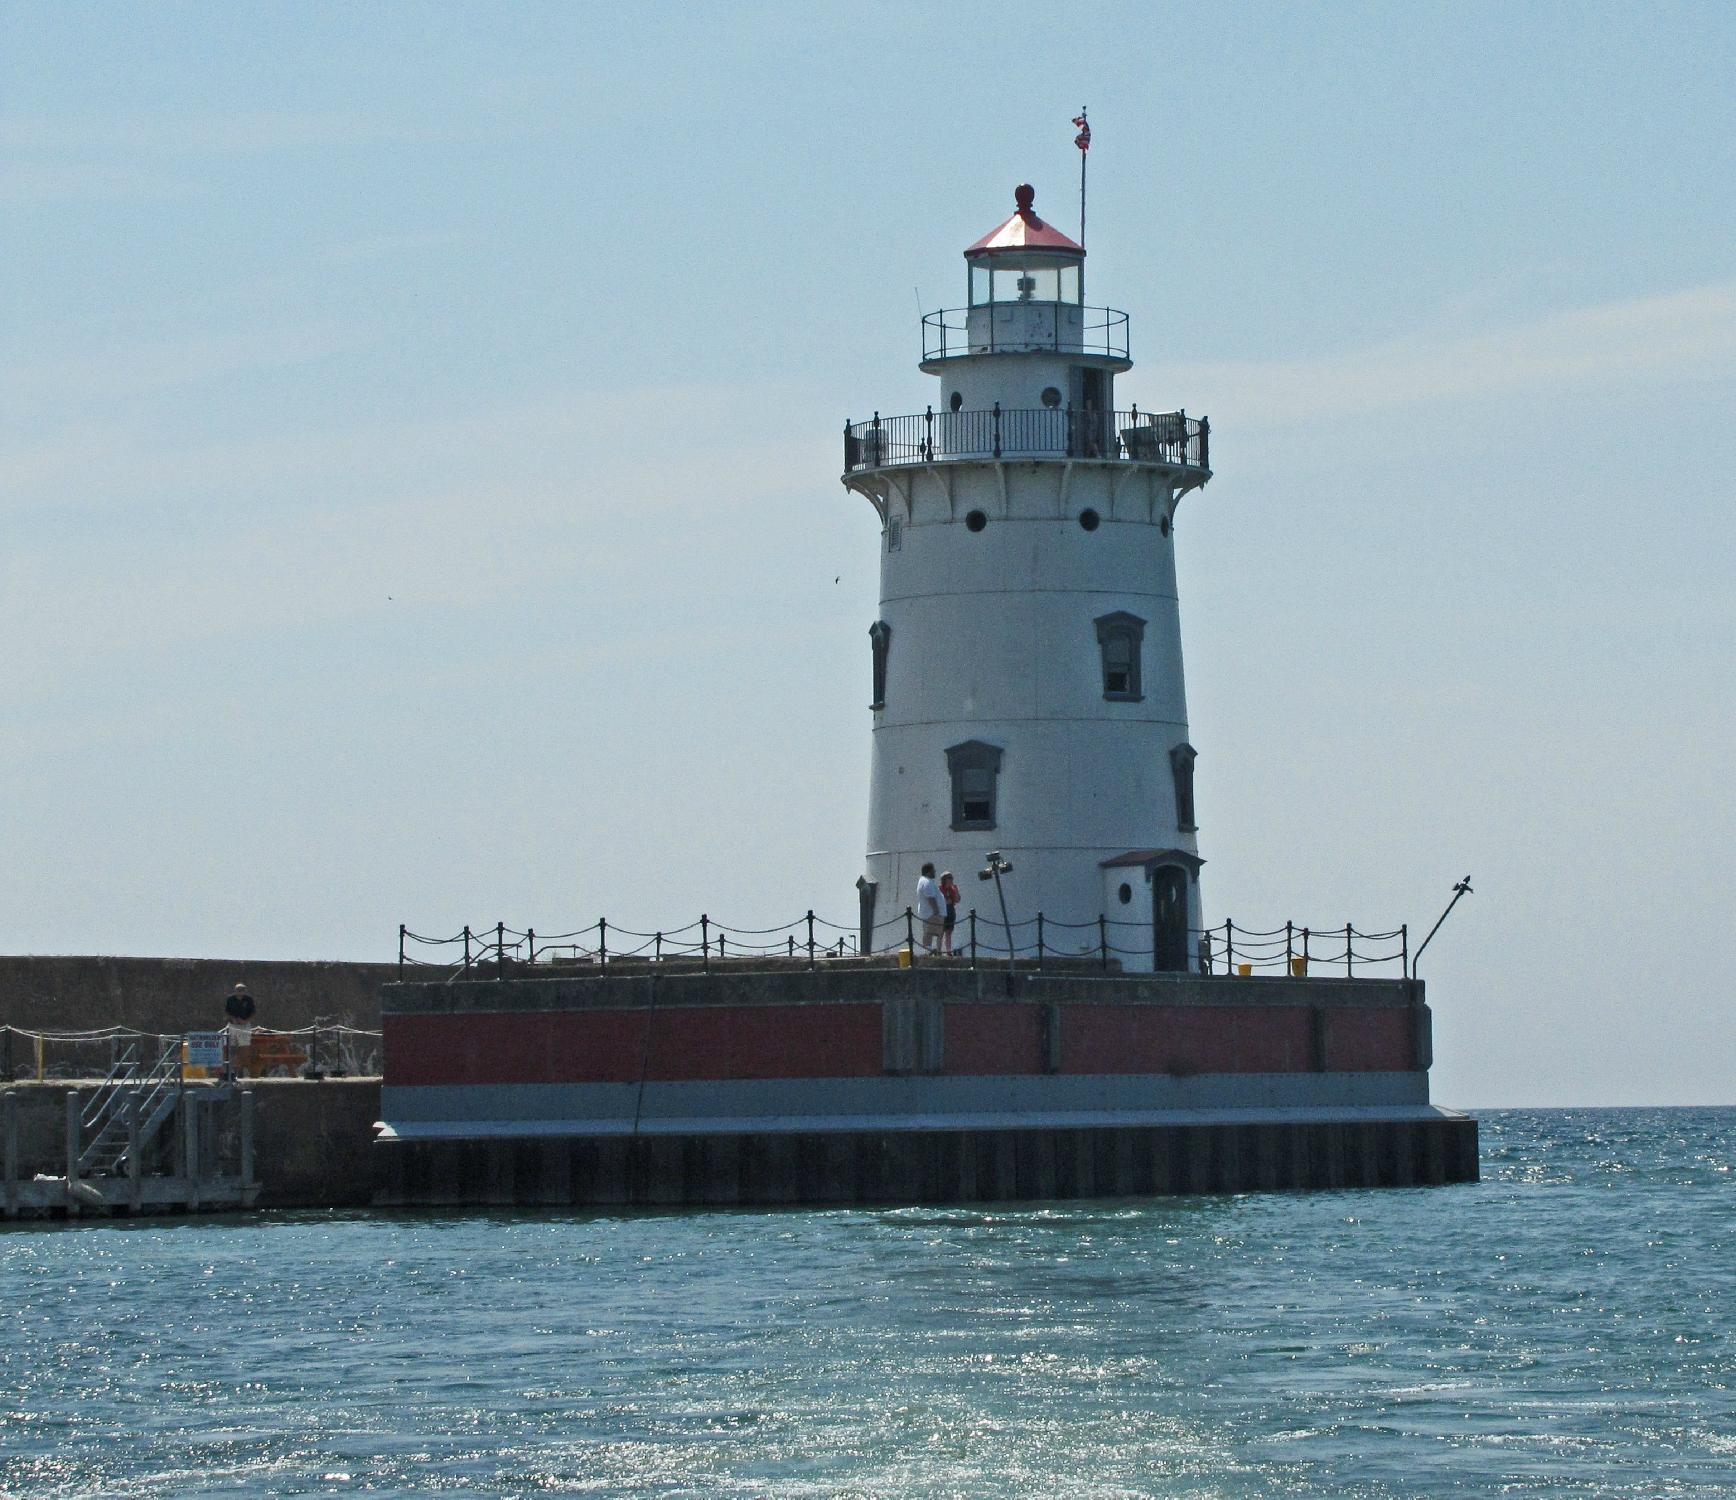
top-left (0, 3), bottom-right (1736, 1106)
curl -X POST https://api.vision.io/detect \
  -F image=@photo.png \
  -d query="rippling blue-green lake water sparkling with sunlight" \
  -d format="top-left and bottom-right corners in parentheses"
top-left (0, 1109), bottom-right (1736, 1500)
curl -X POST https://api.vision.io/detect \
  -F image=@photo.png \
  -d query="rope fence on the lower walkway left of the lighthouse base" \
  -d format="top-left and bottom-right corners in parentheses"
top-left (0, 1023), bottom-right (380, 1082)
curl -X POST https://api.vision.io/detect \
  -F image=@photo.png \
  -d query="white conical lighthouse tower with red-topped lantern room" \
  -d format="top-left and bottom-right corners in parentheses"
top-left (844, 188), bottom-right (1210, 969)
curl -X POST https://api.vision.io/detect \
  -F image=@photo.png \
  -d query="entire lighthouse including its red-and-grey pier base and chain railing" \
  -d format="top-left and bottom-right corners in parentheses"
top-left (375, 184), bottom-right (1477, 1205)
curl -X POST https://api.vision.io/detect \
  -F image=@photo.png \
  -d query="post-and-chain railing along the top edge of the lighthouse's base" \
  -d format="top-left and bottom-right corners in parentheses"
top-left (398, 906), bottom-right (1410, 983)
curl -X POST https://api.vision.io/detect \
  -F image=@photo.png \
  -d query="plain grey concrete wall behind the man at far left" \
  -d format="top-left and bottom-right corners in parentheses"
top-left (0, 955), bottom-right (398, 1033)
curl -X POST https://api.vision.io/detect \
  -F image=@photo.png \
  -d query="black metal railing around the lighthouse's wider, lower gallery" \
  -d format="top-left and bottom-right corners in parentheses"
top-left (844, 405), bottom-right (1212, 474)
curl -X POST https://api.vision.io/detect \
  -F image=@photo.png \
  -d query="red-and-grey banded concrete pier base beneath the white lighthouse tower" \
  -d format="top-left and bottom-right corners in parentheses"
top-left (377, 960), bottom-right (1477, 1205)
